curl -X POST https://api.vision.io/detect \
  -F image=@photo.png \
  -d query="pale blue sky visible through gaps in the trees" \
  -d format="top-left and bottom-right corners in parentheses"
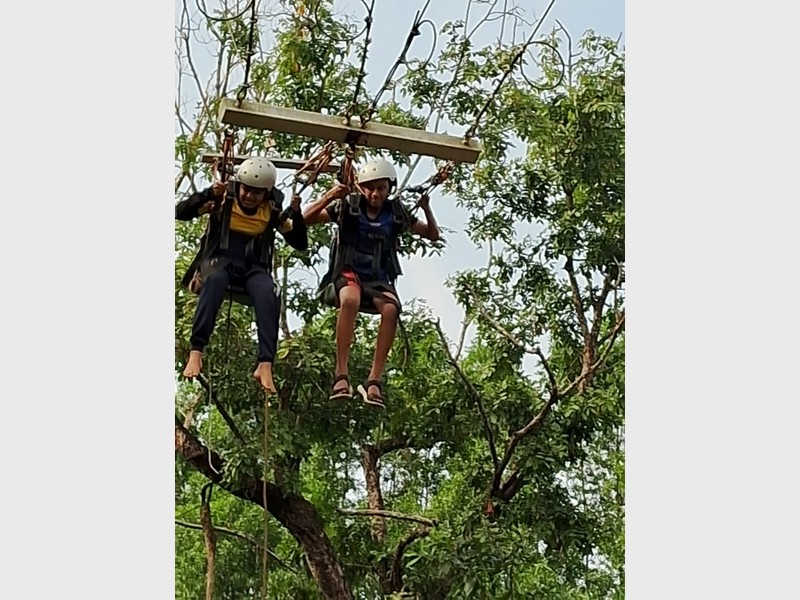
top-left (176, 0), bottom-right (625, 356)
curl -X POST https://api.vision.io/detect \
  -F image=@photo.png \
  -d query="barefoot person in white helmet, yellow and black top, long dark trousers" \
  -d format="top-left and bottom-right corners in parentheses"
top-left (175, 157), bottom-right (308, 393)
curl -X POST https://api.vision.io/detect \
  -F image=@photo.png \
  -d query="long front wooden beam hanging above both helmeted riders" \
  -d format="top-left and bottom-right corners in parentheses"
top-left (219, 98), bottom-right (482, 163)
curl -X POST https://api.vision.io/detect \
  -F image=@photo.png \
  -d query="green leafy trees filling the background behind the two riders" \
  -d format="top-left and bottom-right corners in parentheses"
top-left (175, 0), bottom-right (625, 598)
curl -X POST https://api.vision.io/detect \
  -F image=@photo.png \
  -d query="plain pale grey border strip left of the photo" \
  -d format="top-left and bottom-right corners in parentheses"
top-left (0, 0), bottom-right (175, 600)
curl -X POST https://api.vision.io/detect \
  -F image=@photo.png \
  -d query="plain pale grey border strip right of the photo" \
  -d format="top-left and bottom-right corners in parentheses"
top-left (626, 1), bottom-right (800, 600)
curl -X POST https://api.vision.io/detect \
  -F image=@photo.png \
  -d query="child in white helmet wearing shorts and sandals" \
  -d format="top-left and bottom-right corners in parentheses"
top-left (303, 159), bottom-right (440, 408)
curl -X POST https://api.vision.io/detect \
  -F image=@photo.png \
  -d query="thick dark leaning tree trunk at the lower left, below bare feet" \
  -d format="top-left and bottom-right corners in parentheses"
top-left (175, 419), bottom-right (353, 600)
